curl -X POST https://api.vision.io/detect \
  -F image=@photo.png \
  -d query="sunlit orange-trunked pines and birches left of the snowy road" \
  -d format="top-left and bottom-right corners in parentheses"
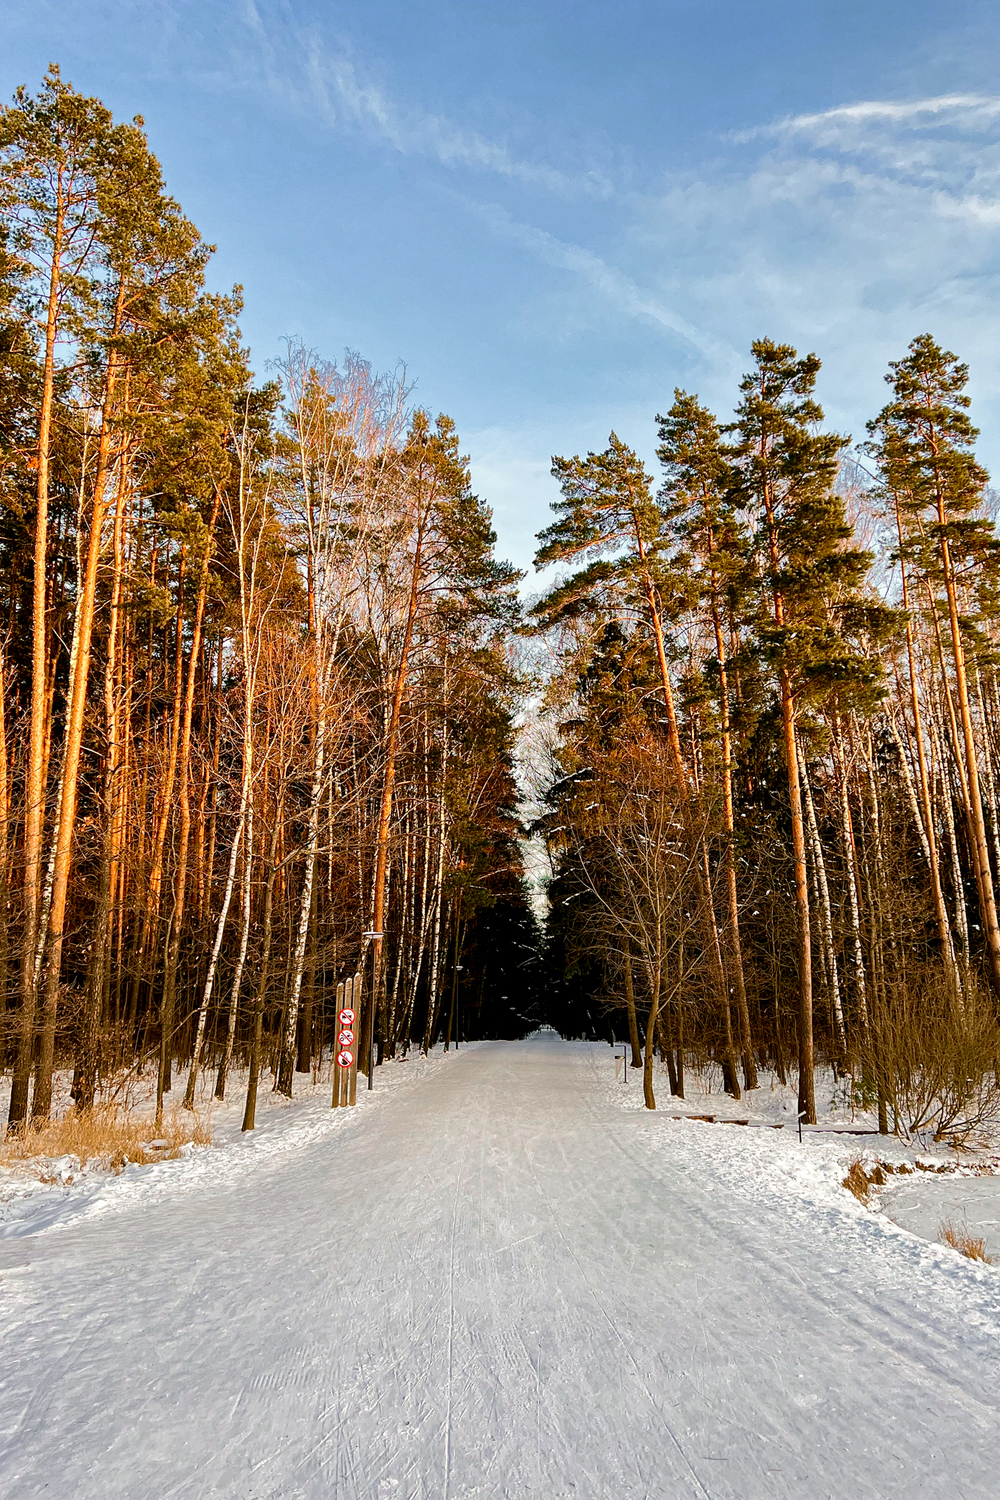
top-left (0, 69), bottom-right (537, 1130)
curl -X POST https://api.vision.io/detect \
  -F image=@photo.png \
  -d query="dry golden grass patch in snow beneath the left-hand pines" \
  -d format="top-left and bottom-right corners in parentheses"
top-left (0, 1104), bottom-right (211, 1181)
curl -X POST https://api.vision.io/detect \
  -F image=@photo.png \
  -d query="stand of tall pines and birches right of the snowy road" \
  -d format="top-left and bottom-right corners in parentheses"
top-left (534, 336), bottom-right (1000, 1137)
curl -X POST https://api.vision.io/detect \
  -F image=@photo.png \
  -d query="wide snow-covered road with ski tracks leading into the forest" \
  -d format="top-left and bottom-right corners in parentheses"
top-left (0, 1035), bottom-right (1000, 1500)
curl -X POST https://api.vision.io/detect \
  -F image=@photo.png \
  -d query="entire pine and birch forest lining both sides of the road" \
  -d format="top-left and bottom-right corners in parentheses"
top-left (0, 69), bottom-right (1000, 1139)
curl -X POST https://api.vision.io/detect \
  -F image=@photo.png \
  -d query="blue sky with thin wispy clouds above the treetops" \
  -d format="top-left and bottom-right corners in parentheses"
top-left (0, 0), bottom-right (1000, 566)
